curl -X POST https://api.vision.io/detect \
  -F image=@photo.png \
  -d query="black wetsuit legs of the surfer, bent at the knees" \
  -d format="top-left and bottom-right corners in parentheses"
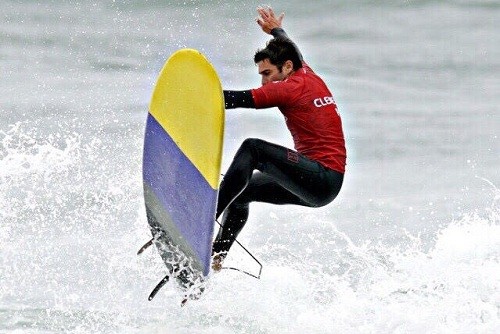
top-left (213, 139), bottom-right (343, 253)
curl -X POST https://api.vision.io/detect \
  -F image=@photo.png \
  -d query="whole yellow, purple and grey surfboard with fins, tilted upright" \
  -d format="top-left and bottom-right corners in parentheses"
top-left (139, 49), bottom-right (224, 300)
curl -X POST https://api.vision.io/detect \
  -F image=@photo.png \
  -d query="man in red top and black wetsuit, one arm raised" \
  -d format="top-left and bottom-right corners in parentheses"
top-left (212, 7), bottom-right (346, 271)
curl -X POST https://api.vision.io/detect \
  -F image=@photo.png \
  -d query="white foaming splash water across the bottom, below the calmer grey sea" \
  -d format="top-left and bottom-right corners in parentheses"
top-left (0, 123), bottom-right (500, 333)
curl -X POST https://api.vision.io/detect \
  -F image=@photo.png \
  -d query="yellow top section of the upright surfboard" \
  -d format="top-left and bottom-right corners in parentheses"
top-left (149, 49), bottom-right (224, 189)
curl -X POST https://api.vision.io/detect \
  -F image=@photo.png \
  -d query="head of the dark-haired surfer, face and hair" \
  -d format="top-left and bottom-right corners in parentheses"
top-left (254, 37), bottom-right (302, 85)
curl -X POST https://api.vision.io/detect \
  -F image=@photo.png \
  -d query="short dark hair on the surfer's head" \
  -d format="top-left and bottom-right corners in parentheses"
top-left (253, 37), bottom-right (302, 71)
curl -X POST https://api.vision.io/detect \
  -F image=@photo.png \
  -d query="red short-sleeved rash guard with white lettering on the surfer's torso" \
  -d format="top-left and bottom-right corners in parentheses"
top-left (252, 62), bottom-right (346, 173)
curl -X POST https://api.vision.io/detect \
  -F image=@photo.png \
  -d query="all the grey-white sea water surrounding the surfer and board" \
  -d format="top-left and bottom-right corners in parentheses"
top-left (0, 0), bottom-right (500, 333)
